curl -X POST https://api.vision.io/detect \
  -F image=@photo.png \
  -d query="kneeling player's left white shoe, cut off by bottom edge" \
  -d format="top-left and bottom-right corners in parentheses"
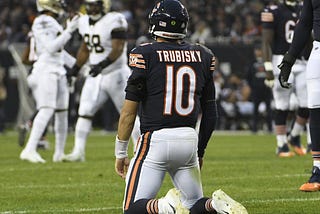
top-left (158, 188), bottom-right (190, 214)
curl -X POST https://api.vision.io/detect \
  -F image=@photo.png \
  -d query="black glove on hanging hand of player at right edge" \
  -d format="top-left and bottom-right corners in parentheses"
top-left (278, 53), bottom-right (296, 88)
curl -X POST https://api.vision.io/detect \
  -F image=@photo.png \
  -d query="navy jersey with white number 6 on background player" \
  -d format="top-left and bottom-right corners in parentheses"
top-left (261, 4), bottom-right (300, 55)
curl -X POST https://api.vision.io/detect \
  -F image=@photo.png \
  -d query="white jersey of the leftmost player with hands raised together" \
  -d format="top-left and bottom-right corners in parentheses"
top-left (32, 14), bottom-right (71, 73)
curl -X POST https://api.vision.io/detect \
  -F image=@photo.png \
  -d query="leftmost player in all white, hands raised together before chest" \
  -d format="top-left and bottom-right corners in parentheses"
top-left (20, 0), bottom-right (79, 163)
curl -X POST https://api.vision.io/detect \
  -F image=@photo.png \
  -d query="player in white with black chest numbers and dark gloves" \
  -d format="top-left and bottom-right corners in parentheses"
top-left (65, 0), bottom-right (140, 161)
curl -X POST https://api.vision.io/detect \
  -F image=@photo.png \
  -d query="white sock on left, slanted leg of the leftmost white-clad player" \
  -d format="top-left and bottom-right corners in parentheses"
top-left (25, 108), bottom-right (54, 151)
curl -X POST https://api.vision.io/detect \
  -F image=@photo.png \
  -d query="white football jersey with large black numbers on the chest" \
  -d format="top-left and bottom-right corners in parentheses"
top-left (79, 12), bottom-right (128, 74)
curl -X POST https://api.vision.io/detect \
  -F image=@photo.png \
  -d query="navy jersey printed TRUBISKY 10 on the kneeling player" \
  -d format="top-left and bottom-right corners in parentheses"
top-left (126, 42), bottom-right (215, 133)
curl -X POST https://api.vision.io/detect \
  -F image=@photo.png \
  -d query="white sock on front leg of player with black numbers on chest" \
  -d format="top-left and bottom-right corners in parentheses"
top-left (73, 117), bottom-right (92, 154)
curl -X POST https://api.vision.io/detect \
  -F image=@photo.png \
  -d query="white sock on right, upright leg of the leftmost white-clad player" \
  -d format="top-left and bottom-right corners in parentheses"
top-left (54, 111), bottom-right (68, 154)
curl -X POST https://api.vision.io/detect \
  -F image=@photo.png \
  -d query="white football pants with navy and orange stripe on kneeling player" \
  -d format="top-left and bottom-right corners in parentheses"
top-left (123, 127), bottom-right (203, 210)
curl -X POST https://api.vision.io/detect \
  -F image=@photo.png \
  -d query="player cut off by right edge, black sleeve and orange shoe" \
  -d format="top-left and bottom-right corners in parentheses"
top-left (279, 0), bottom-right (320, 192)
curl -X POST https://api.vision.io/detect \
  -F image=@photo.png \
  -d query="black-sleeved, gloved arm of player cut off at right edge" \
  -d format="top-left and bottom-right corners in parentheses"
top-left (278, 0), bottom-right (313, 88)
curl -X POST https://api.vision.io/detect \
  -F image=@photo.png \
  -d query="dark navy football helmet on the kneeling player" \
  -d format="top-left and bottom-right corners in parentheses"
top-left (149, 0), bottom-right (189, 40)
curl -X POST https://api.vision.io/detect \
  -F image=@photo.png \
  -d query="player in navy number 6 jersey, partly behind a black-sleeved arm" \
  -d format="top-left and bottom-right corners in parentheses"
top-left (261, 0), bottom-right (311, 157)
